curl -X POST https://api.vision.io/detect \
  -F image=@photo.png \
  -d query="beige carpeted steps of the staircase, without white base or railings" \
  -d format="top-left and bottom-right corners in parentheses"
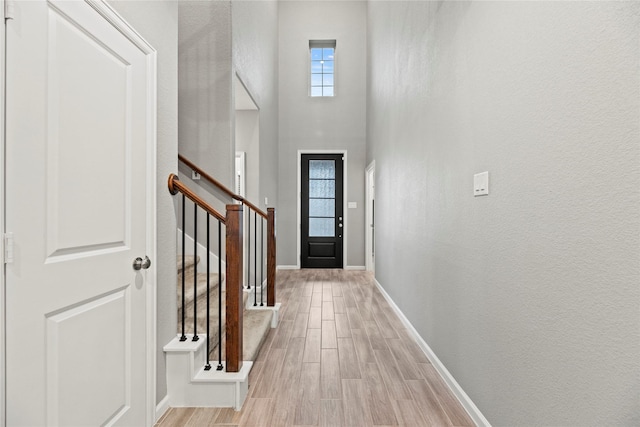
top-left (176, 256), bottom-right (277, 366)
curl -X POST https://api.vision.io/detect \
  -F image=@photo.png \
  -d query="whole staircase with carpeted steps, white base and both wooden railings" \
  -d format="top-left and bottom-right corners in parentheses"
top-left (163, 156), bottom-right (280, 410)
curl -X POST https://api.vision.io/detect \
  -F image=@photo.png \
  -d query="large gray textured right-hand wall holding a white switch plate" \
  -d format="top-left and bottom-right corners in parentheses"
top-left (367, 1), bottom-right (640, 426)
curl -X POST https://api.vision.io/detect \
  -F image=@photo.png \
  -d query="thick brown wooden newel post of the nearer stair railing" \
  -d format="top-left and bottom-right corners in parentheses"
top-left (226, 204), bottom-right (243, 372)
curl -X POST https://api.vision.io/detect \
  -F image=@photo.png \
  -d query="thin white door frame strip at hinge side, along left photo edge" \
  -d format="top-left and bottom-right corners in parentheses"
top-left (0, 0), bottom-right (7, 427)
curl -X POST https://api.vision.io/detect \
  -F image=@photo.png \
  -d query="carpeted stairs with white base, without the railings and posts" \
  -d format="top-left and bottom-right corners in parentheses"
top-left (164, 256), bottom-right (280, 411)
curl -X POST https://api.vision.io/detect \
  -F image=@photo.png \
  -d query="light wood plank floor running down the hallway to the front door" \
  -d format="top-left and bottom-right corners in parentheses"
top-left (157, 270), bottom-right (474, 427)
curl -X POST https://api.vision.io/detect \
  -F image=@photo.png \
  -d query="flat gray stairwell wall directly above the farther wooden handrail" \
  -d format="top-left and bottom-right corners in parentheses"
top-left (178, 0), bottom-right (235, 188)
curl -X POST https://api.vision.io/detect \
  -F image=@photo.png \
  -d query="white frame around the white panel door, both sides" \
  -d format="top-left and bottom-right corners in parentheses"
top-left (0, 0), bottom-right (158, 427)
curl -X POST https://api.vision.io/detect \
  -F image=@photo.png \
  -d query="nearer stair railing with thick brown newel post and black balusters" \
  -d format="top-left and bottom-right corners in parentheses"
top-left (168, 174), bottom-right (243, 372)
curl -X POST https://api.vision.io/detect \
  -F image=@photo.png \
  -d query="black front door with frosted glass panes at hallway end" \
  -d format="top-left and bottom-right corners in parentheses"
top-left (300, 154), bottom-right (344, 268)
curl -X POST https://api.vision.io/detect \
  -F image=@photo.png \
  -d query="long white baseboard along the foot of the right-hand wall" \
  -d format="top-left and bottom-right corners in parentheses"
top-left (374, 279), bottom-right (491, 427)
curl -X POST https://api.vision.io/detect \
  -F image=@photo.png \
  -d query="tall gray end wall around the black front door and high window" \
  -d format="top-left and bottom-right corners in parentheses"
top-left (277, 1), bottom-right (367, 267)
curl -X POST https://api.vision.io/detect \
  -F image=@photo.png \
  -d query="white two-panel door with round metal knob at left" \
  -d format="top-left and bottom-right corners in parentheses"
top-left (6, 0), bottom-right (155, 426)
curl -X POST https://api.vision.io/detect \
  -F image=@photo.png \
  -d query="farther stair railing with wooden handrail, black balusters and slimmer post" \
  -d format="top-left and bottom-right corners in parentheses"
top-left (178, 154), bottom-right (276, 307)
